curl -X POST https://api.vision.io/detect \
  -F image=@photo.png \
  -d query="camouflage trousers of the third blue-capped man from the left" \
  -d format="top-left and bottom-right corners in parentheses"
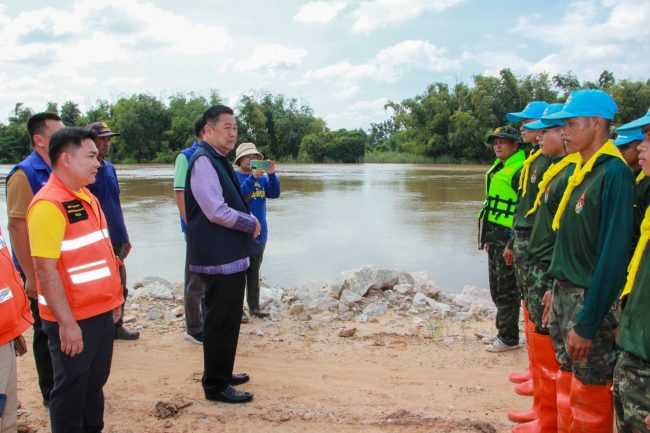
top-left (548, 280), bottom-right (619, 385)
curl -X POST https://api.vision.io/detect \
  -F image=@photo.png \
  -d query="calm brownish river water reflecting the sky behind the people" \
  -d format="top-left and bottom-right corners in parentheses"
top-left (0, 164), bottom-right (488, 292)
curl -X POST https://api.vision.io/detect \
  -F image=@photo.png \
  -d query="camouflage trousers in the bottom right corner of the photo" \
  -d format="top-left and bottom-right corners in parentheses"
top-left (614, 352), bottom-right (650, 433)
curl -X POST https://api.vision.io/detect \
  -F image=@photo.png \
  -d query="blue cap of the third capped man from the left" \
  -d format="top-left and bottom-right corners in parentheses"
top-left (542, 90), bottom-right (618, 123)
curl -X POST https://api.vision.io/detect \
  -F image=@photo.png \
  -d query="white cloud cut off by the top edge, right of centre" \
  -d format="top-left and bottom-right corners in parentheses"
top-left (352, 0), bottom-right (465, 34)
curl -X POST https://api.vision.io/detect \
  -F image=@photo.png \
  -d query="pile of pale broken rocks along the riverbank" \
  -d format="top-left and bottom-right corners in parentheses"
top-left (130, 266), bottom-right (496, 323)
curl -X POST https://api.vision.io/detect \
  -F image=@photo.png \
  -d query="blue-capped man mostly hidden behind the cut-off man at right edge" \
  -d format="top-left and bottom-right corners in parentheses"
top-left (614, 128), bottom-right (650, 248)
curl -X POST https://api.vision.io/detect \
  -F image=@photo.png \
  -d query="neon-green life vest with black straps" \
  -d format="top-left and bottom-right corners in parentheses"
top-left (479, 149), bottom-right (526, 228)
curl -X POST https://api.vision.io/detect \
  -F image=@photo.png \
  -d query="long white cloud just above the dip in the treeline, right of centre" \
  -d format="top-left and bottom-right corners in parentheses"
top-left (306, 40), bottom-right (461, 87)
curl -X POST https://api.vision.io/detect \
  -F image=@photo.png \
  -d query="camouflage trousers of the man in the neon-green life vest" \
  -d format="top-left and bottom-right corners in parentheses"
top-left (484, 222), bottom-right (520, 346)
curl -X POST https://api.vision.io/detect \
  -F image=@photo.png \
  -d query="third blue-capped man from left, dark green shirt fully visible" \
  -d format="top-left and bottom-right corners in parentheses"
top-left (542, 90), bottom-right (634, 433)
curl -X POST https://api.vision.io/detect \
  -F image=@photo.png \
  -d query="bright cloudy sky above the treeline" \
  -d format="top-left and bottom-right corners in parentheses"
top-left (0, 0), bottom-right (650, 128)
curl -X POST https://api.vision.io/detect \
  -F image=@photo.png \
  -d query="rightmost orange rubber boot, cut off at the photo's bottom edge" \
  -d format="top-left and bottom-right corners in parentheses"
top-left (569, 376), bottom-right (614, 433)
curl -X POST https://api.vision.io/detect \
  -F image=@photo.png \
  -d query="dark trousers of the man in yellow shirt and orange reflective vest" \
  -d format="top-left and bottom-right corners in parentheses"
top-left (43, 311), bottom-right (115, 433)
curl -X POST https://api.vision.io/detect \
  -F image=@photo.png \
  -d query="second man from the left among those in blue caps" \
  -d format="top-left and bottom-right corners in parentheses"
top-left (508, 104), bottom-right (579, 433)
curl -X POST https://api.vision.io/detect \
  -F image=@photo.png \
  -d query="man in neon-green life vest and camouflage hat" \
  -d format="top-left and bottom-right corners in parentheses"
top-left (479, 126), bottom-right (526, 352)
